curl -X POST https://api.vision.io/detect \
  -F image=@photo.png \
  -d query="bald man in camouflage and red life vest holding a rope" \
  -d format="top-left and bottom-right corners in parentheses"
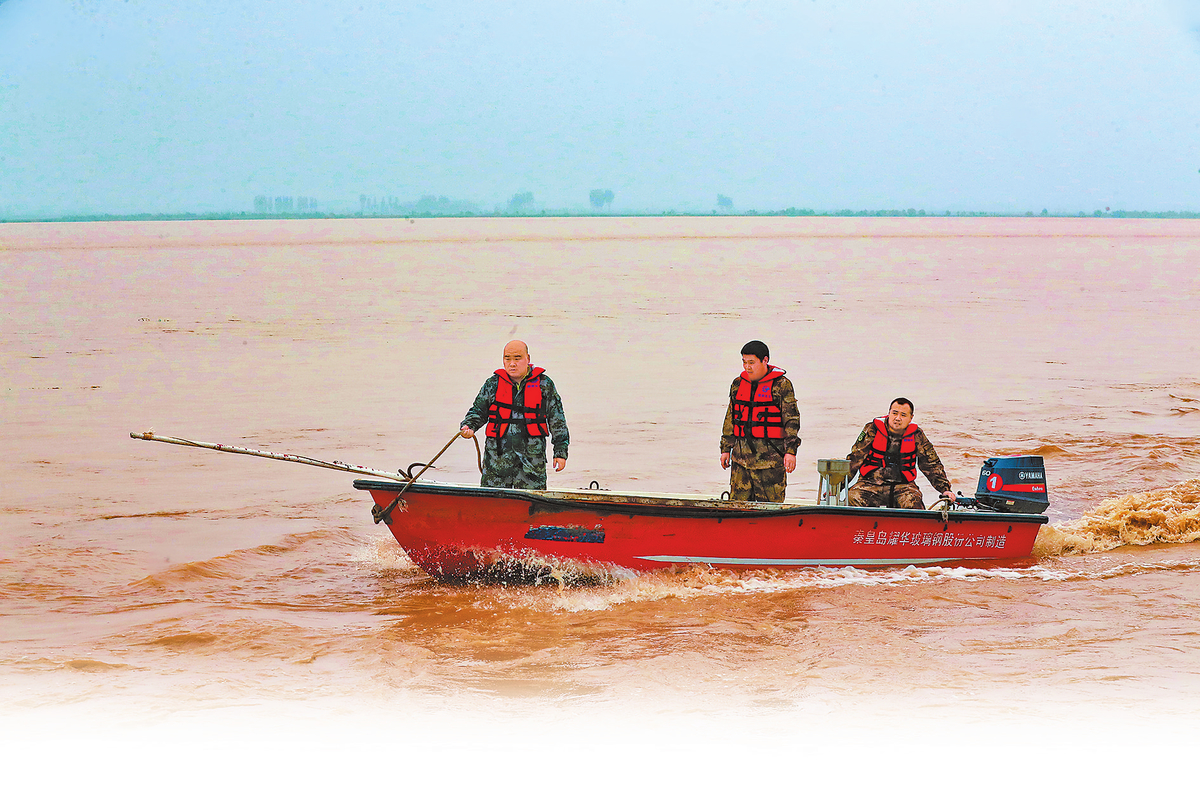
top-left (461, 339), bottom-right (571, 489)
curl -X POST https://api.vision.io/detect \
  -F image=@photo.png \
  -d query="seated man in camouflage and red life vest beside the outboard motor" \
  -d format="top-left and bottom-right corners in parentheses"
top-left (846, 397), bottom-right (954, 509)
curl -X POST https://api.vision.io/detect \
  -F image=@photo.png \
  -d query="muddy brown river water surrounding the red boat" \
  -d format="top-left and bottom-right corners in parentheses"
top-left (0, 218), bottom-right (1200, 794)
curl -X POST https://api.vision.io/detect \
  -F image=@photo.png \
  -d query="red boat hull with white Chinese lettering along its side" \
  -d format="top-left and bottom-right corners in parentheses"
top-left (354, 480), bottom-right (1048, 581)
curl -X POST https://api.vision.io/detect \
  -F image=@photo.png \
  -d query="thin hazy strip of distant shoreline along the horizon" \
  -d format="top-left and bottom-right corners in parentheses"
top-left (0, 209), bottom-right (1200, 224)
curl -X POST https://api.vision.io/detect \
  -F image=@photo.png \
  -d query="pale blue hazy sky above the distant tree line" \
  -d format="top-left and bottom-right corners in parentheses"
top-left (0, 0), bottom-right (1200, 218)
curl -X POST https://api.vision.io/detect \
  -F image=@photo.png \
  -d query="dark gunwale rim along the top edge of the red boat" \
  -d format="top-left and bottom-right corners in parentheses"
top-left (354, 480), bottom-right (1050, 525)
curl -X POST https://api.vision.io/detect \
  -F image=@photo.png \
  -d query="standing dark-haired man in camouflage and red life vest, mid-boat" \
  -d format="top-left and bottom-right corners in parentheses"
top-left (721, 339), bottom-right (800, 503)
